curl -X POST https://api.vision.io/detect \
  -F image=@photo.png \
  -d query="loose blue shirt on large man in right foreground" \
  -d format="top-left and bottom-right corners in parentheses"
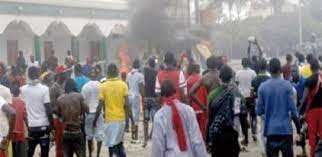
top-left (256, 78), bottom-right (299, 136)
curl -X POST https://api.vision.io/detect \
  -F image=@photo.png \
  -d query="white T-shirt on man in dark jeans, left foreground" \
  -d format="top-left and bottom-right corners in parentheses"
top-left (21, 83), bottom-right (50, 127)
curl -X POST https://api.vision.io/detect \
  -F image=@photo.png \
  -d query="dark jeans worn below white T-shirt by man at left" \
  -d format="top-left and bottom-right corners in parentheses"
top-left (28, 129), bottom-right (49, 157)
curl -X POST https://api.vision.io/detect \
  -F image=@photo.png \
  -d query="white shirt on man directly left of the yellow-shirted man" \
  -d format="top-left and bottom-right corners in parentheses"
top-left (81, 81), bottom-right (101, 113)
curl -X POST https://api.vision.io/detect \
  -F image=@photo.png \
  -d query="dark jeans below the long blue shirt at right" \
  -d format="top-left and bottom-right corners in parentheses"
top-left (266, 135), bottom-right (294, 157)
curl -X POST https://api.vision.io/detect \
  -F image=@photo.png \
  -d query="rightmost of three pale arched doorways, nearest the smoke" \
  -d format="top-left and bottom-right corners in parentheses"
top-left (78, 24), bottom-right (104, 62)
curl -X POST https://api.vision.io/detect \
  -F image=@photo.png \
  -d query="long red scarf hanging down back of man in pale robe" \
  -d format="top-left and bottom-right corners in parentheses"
top-left (163, 96), bottom-right (187, 151)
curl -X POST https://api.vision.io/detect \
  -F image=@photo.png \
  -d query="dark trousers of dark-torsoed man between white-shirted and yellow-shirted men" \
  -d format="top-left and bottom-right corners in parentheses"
top-left (63, 131), bottom-right (86, 157)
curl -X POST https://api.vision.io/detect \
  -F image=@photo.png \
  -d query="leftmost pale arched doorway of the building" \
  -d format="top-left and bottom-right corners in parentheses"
top-left (3, 20), bottom-right (35, 65)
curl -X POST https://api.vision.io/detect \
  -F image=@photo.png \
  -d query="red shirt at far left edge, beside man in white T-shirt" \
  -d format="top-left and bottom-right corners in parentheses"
top-left (11, 97), bottom-right (26, 141)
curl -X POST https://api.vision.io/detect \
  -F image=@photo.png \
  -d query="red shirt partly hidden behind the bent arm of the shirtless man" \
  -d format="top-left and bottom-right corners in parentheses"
top-left (187, 74), bottom-right (208, 113)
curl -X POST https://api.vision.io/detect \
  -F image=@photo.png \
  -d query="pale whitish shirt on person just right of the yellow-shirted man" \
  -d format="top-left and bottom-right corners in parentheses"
top-left (126, 69), bottom-right (144, 96)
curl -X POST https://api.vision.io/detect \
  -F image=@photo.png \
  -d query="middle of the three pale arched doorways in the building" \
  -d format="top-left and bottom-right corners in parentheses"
top-left (41, 21), bottom-right (72, 64)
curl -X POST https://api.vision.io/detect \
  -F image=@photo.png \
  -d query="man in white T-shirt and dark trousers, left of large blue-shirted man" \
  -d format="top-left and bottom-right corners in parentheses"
top-left (236, 58), bottom-right (257, 146)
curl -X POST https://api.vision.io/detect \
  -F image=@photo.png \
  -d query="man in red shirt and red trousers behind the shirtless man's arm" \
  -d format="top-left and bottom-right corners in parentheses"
top-left (187, 64), bottom-right (208, 140)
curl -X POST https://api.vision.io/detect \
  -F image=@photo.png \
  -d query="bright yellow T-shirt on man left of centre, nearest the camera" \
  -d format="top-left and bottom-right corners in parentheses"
top-left (99, 78), bottom-right (128, 122)
